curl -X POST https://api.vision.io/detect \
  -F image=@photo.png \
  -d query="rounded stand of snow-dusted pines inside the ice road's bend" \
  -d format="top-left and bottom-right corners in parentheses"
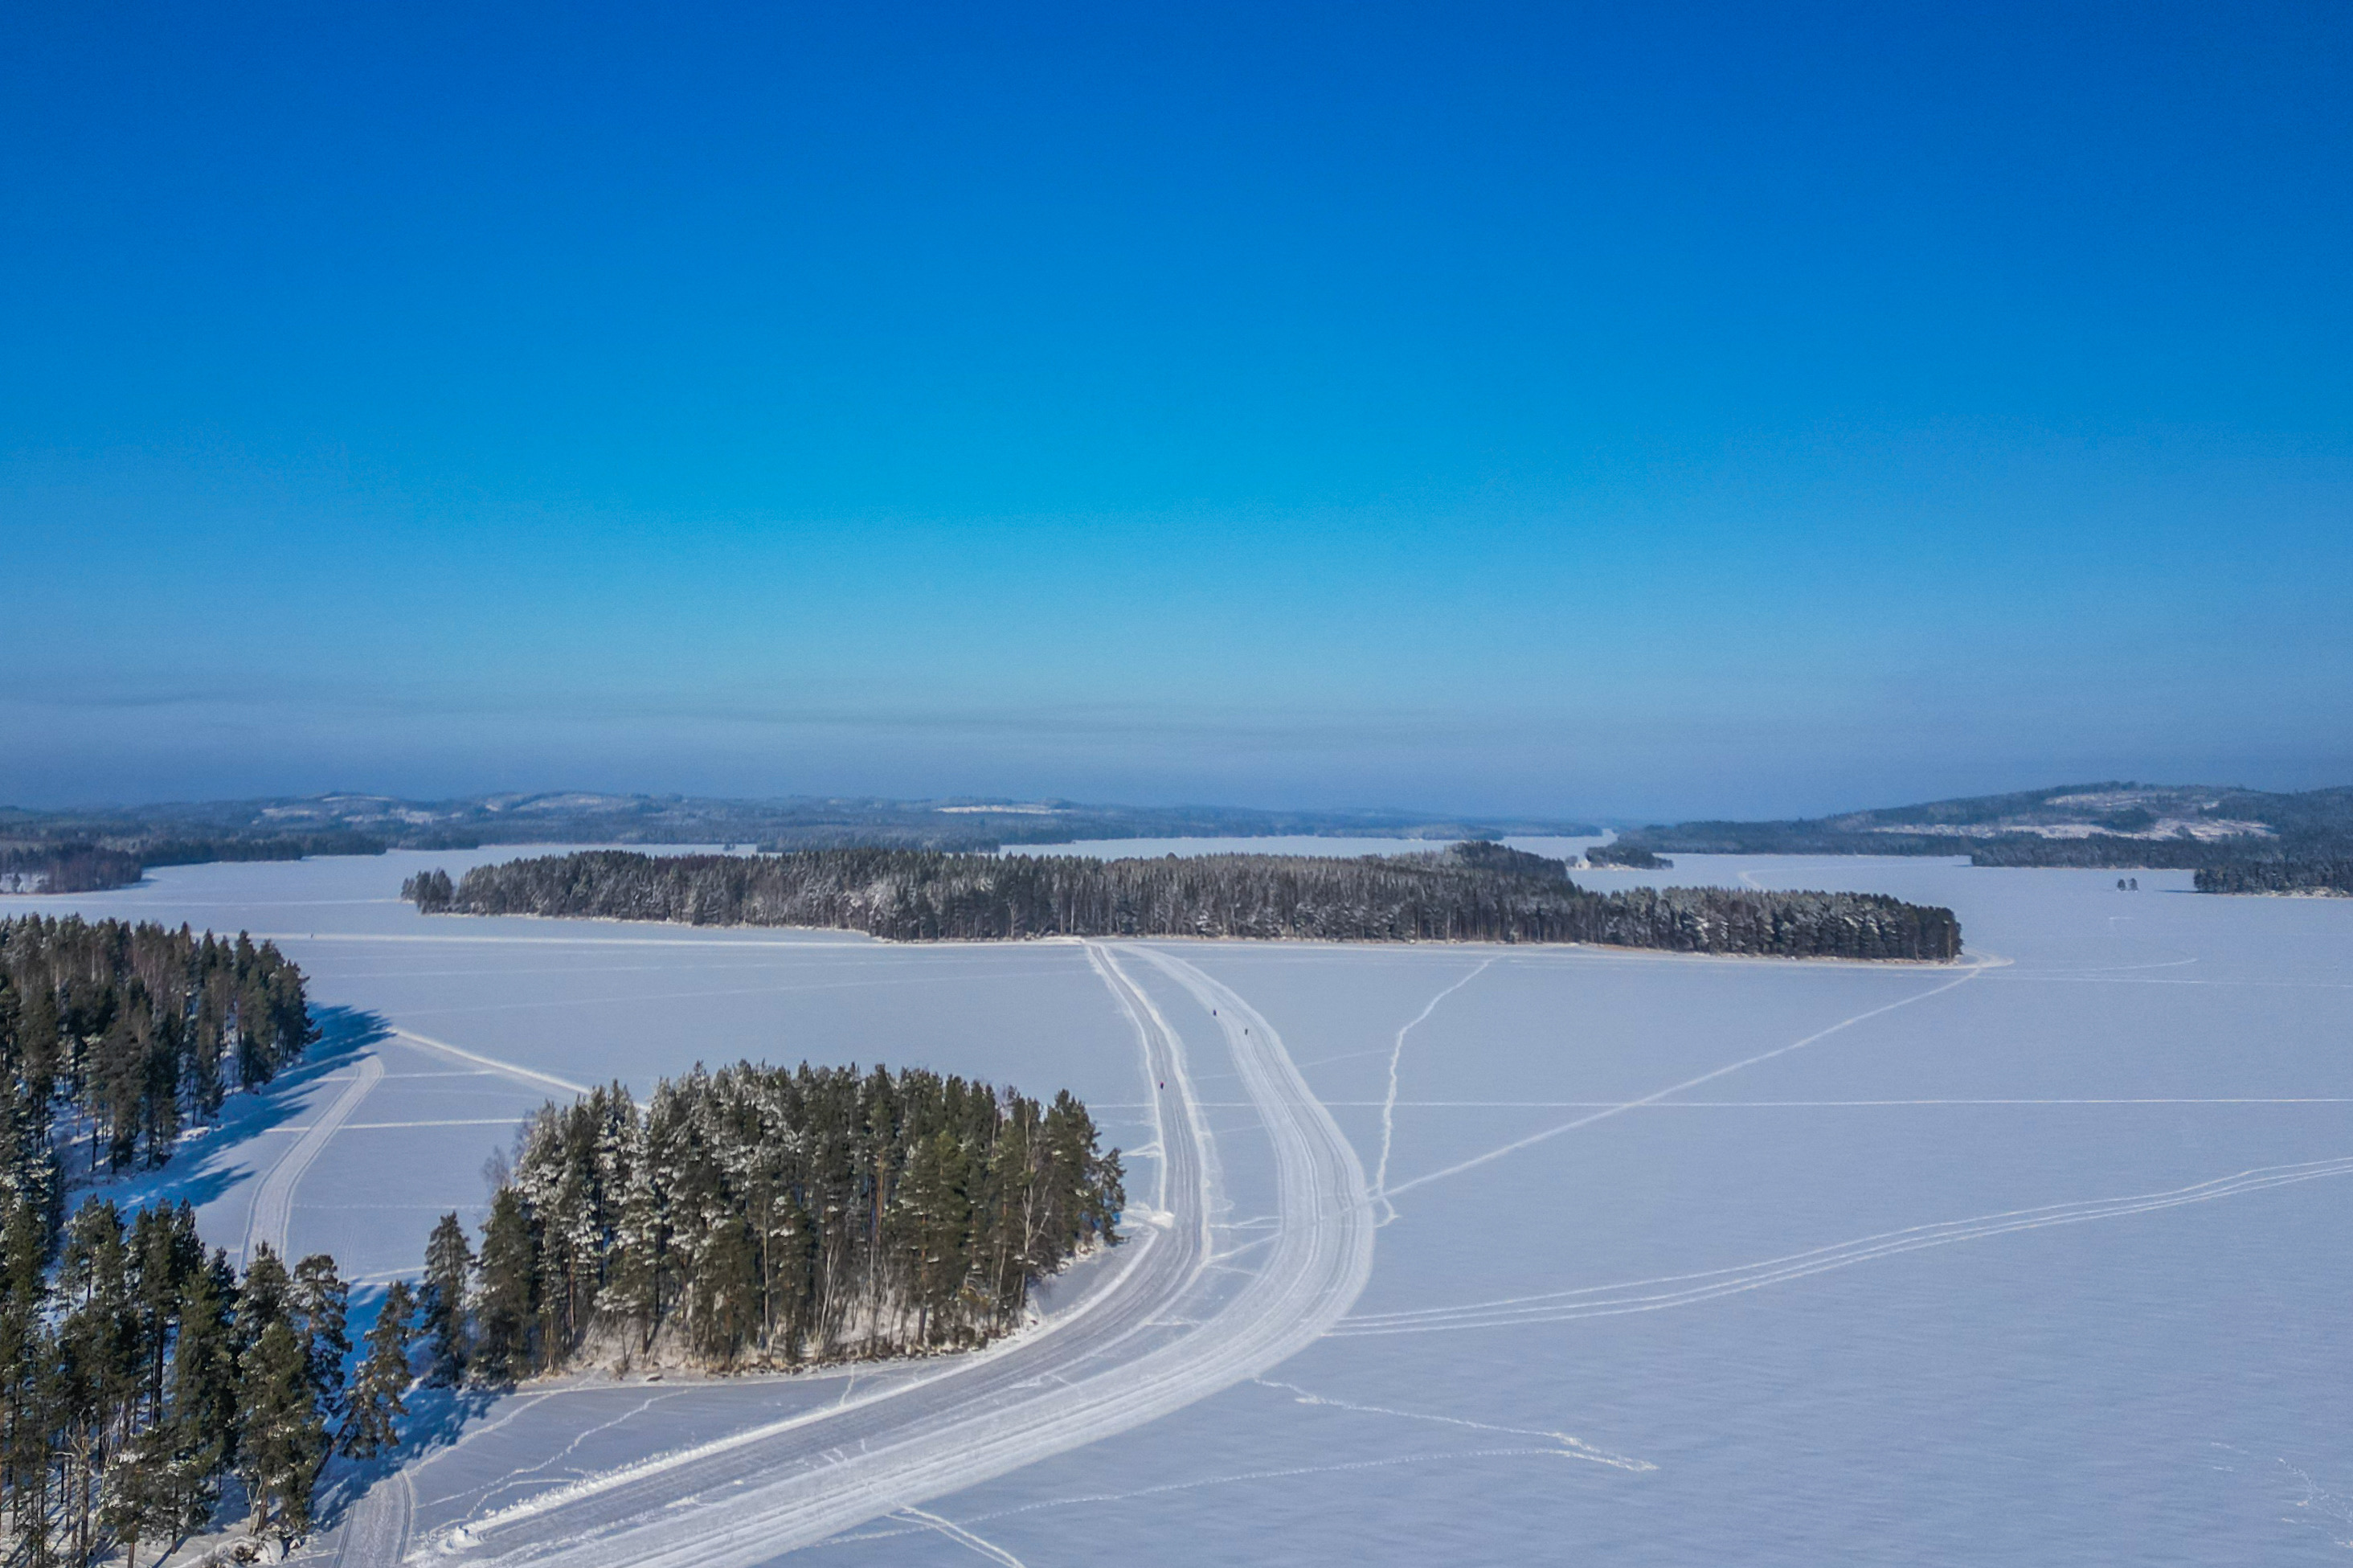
top-left (424, 1062), bottom-right (1125, 1385)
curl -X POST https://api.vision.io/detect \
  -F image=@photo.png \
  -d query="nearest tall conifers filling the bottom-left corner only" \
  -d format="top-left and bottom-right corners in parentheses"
top-left (0, 1198), bottom-right (411, 1568)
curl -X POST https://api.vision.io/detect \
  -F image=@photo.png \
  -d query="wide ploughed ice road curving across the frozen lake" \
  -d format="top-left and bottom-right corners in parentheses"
top-left (342, 942), bottom-right (1374, 1568)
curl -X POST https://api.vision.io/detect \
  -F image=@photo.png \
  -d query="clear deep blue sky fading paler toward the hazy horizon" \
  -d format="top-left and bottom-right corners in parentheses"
top-left (0, 2), bottom-right (2353, 817)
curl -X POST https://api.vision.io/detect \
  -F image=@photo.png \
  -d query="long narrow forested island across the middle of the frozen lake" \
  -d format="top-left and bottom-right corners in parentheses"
top-left (403, 843), bottom-right (1960, 960)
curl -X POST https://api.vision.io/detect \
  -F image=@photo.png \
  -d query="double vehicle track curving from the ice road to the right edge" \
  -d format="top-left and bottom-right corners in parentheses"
top-left (1332, 1158), bottom-right (2353, 1340)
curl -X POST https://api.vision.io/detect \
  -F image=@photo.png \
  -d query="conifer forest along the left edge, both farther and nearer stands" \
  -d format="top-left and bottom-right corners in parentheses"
top-left (0, 918), bottom-right (371, 1568)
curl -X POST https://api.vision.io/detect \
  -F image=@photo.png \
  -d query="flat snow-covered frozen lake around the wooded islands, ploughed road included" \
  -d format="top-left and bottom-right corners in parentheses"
top-left (18, 850), bottom-right (2353, 1568)
